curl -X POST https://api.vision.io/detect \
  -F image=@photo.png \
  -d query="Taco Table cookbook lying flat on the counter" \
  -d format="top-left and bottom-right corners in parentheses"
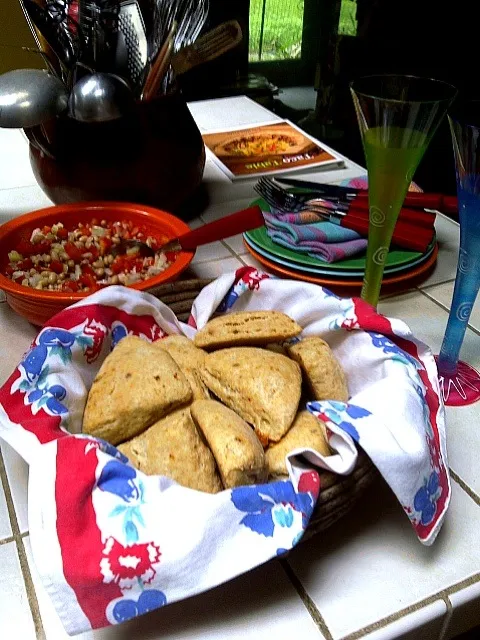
top-left (202, 120), bottom-right (344, 180)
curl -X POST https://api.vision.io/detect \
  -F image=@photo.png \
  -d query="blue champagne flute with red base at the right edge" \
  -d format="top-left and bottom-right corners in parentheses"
top-left (437, 100), bottom-right (480, 406)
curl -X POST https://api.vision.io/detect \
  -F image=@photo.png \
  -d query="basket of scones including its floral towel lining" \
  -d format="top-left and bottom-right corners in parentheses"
top-left (0, 267), bottom-right (450, 634)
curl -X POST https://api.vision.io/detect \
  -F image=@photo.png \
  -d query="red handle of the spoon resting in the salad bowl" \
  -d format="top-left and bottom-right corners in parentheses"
top-left (178, 206), bottom-right (265, 251)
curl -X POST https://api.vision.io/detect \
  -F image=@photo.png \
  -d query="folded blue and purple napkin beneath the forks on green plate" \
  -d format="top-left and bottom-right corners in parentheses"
top-left (263, 210), bottom-right (367, 262)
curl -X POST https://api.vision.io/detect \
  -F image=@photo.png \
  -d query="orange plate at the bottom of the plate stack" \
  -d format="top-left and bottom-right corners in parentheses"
top-left (243, 240), bottom-right (438, 291)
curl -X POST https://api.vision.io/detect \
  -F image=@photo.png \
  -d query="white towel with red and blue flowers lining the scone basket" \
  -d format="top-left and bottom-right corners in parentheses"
top-left (0, 267), bottom-right (450, 634)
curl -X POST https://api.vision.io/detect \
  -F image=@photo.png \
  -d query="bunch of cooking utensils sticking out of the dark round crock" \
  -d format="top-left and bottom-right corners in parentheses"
top-left (0, 0), bottom-right (242, 128)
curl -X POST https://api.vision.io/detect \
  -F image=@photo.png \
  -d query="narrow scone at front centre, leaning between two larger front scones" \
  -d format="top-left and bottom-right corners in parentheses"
top-left (190, 400), bottom-right (267, 489)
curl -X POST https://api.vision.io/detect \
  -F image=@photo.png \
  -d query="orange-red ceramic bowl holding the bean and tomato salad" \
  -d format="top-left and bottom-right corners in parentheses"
top-left (0, 202), bottom-right (194, 326)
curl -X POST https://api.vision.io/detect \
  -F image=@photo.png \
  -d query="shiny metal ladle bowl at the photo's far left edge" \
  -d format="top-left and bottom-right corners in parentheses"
top-left (0, 69), bottom-right (68, 129)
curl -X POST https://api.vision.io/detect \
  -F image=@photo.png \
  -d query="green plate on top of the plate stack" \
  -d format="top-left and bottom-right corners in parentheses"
top-left (245, 198), bottom-right (428, 273)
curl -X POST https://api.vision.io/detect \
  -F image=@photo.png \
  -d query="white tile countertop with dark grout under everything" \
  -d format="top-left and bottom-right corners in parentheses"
top-left (0, 97), bottom-right (480, 640)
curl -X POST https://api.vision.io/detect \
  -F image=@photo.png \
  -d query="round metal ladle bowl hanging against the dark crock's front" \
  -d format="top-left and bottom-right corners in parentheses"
top-left (68, 73), bottom-right (134, 122)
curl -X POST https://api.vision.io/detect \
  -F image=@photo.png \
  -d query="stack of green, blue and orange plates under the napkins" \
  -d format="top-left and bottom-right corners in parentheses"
top-left (243, 200), bottom-right (438, 287)
